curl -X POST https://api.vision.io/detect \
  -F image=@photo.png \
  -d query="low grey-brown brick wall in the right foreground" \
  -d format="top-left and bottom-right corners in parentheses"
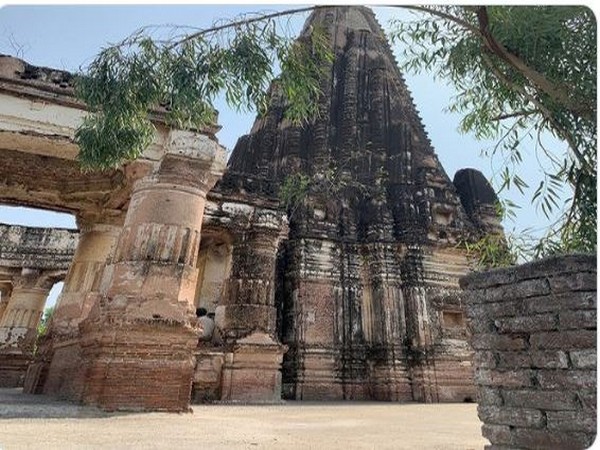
top-left (461, 255), bottom-right (596, 450)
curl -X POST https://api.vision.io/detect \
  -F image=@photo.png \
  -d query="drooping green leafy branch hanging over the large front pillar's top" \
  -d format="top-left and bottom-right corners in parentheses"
top-left (75, 8), bottom-right (333, 169)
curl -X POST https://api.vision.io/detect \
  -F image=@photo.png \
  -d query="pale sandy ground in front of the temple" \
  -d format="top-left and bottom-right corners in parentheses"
top-left (0, 389), bottom-right (488, 450)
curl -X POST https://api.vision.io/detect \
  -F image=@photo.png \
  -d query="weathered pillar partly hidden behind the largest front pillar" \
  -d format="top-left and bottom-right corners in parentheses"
top-left (31, 214), bottom-right (123, 400)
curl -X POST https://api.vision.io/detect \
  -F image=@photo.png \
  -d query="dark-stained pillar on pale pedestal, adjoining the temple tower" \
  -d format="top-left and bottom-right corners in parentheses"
top-left (216, 226), bottom-right (287, 403)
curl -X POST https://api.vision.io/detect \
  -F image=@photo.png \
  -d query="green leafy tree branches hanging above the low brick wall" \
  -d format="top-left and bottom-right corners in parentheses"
top-left (392, 6), bottom-right (597, 255)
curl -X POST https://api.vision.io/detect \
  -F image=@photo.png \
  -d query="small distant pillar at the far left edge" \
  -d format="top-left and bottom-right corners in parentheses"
top-left (0, 268), bottom-right (55, 387)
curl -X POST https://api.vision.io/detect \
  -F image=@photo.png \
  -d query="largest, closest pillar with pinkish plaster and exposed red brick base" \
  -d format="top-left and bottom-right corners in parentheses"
top-left (80, 131), bottom-right (225, 411)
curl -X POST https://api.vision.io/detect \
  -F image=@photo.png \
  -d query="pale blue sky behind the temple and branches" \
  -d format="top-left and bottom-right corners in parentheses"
top-left (0, 4), bottom-right (565, 306)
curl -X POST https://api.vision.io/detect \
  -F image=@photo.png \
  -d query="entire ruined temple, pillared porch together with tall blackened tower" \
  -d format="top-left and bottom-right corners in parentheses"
top-left (0, 7), bottom-right (500, 410)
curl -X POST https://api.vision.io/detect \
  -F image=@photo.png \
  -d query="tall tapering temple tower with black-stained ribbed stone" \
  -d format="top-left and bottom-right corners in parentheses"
top-left (221, 6), bottom-right (499, 402)
